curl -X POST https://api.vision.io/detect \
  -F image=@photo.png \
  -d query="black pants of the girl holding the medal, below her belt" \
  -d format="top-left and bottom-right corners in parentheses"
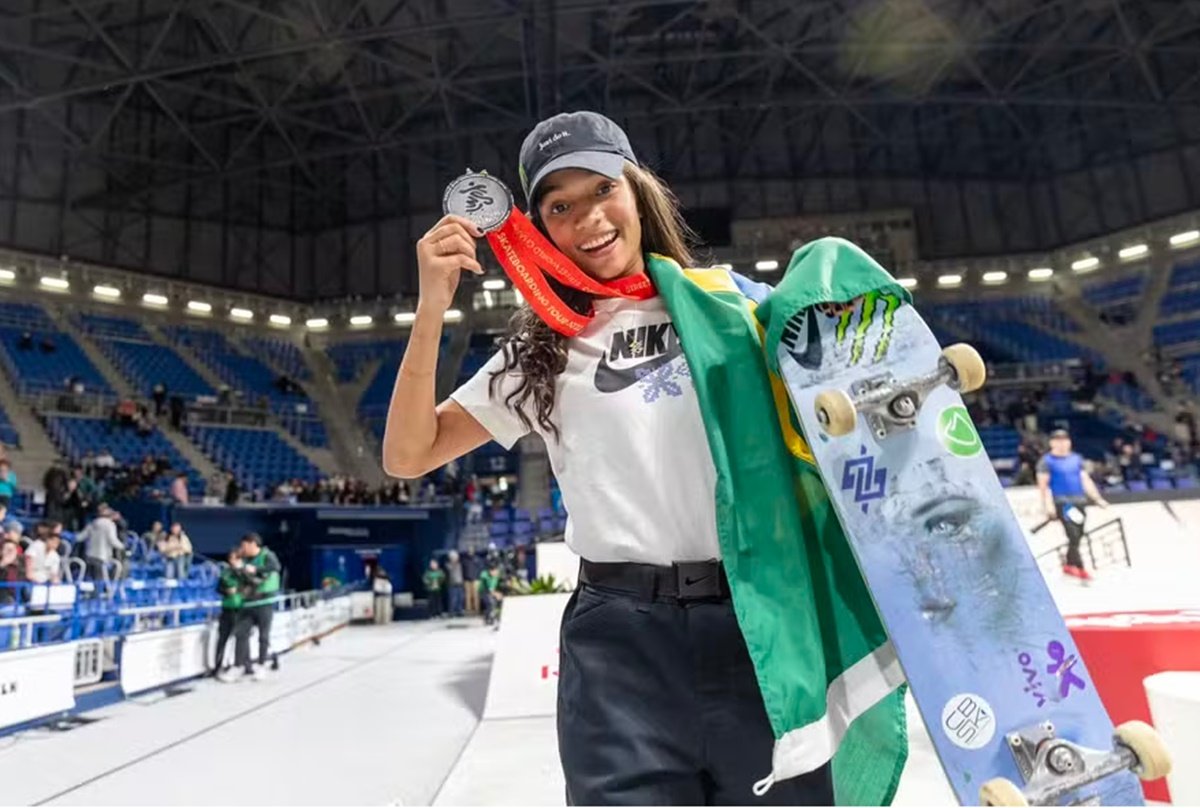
top-left (558, 585), bottom-right (833, 806)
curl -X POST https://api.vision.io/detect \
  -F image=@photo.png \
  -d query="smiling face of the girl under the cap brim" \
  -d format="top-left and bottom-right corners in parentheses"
top-left (538, 168), bottom-right (646, 281)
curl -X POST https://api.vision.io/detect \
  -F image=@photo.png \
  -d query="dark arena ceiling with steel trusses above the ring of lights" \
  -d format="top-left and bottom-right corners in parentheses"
top-left (0, 0), bottom-right (1200, 297)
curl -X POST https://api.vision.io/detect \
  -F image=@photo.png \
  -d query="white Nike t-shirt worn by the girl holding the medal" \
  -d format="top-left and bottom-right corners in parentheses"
top-left (451, 292), bottom-right (720, 565)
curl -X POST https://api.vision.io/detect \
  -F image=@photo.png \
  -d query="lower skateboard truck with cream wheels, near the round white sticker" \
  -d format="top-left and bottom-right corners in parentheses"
top-left (979, 722), bottom-right (1171, 806)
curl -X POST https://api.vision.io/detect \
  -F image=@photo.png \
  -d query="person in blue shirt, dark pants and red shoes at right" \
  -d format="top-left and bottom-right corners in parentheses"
top-left (1038, 430), bottom-right (1109, 581)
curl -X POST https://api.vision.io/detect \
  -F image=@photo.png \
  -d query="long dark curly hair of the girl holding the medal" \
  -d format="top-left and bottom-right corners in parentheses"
top-left (488, 162), bottom-right (697, 441)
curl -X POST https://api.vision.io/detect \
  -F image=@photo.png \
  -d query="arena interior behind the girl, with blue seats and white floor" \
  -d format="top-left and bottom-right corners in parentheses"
top-left (0, 0), bottom-right (1200, 806)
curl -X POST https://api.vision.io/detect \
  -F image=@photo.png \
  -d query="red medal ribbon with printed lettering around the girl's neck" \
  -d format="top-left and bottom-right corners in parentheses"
top-left (487, 208), bottom-right (655, 336)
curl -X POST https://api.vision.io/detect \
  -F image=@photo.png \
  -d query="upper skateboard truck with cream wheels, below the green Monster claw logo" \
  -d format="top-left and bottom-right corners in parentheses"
top-left (815, 345), bottom-right (986, 441)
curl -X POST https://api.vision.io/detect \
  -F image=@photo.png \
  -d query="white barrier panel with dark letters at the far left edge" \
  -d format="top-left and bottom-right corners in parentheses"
top-left (0, 642), bottom-right (76, 728)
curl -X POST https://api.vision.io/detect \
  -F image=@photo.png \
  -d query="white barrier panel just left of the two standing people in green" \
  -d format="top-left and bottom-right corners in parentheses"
top-left (121, 623), bottom-right (216, 695)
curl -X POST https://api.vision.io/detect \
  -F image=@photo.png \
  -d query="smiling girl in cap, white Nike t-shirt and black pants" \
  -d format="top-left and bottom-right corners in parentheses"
top-left (383, 112), bottom-right (883, 804)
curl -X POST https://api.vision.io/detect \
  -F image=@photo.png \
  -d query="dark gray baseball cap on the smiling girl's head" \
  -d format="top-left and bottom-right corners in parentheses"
top-left (518, 112), bottom-right (637, 204)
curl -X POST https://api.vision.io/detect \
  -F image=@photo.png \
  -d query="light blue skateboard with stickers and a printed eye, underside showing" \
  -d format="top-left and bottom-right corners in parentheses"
top-left (778, 292), bottom-right (1170, 806)
